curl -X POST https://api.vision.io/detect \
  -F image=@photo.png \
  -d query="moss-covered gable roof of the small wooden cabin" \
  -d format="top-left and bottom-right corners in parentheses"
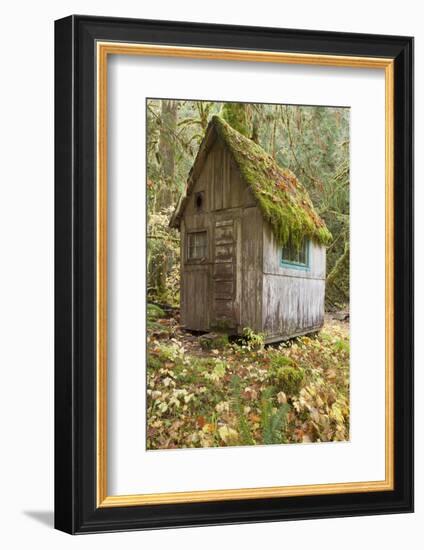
top-left (170, 116), bottom-right (332, 246)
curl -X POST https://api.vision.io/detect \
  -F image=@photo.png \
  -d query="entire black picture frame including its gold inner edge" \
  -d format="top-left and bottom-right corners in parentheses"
top-left (55, 15), bottom-right (413, 534)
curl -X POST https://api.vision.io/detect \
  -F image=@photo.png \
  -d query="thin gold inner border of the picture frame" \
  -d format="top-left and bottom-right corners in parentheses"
top-left (96, 41), bottom-right (394, 507)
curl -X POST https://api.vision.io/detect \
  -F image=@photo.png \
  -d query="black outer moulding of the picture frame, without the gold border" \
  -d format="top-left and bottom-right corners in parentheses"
top-left (55, 15), bottom-right (413, 534)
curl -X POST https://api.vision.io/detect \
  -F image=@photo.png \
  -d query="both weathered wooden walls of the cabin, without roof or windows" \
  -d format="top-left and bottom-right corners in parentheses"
top-left (180, 135), bottom-right (325, 341)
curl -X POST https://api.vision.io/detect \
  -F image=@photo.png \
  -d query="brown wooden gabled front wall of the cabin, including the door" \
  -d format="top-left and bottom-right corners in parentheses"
top-left (180, 137), bottom-right (256, 331)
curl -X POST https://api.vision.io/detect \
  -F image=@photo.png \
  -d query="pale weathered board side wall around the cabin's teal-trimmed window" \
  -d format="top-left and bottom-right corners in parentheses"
top-left (262, 223), bottom-right (326, 341)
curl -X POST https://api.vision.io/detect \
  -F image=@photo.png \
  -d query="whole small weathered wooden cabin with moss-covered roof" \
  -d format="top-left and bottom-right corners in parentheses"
top-left (170, 116), bottom-right (331, 342)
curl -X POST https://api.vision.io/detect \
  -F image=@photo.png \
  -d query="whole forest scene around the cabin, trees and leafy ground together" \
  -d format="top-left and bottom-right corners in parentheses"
top-left (146, 99), bottom-right (350, 449)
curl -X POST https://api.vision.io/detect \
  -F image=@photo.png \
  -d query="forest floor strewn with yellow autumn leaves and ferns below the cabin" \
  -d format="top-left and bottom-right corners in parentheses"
top-left (147, 305), bottom-right (349, 449)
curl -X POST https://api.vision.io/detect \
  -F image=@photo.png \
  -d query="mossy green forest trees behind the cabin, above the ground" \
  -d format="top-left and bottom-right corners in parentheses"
top-left (147, 99), bottom-right (350, 311)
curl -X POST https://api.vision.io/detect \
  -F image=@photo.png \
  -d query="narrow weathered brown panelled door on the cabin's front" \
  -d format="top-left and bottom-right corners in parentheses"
top-left (212, 216), bottom-right (239, 331)
